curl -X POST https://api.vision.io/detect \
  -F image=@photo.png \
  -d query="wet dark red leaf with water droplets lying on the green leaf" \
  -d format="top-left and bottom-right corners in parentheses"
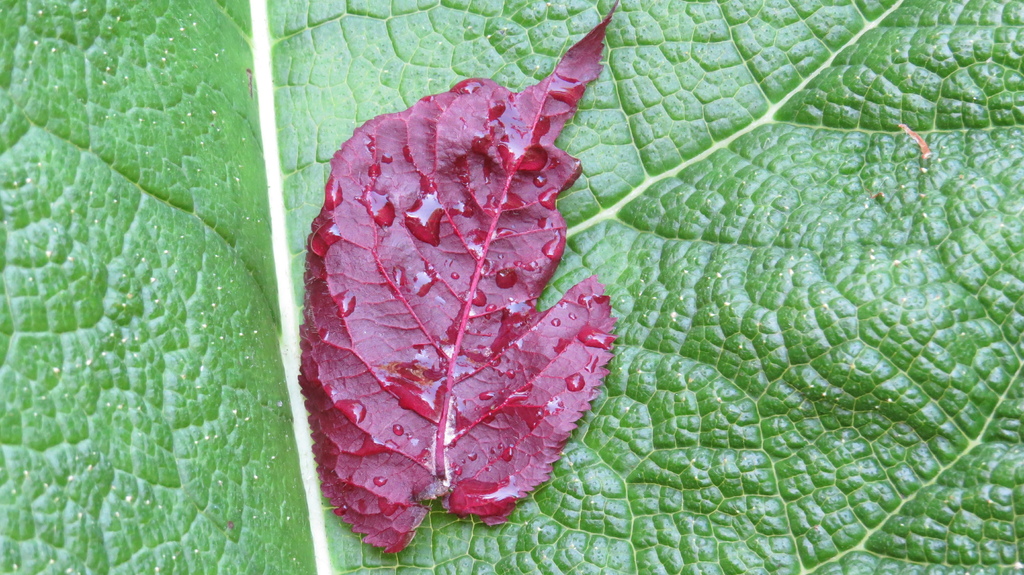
top-left (300, 4), bottom-right (614, 551)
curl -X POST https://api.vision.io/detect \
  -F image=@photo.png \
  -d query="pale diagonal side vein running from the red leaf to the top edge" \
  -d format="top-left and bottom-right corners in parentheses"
top-left (565, 0), bottom-right (903, 236)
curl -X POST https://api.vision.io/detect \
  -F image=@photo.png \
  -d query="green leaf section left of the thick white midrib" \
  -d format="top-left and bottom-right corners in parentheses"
top-left (0, 0), bottom-right (312, 575)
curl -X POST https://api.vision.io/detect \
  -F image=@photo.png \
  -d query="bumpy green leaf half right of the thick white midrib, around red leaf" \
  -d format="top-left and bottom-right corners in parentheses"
top-left (270, 0), bottom-right (1024, 575)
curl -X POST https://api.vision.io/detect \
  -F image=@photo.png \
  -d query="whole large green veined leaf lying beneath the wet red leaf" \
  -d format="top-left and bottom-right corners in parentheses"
top-left (0, 0), bottom-right (1024, 575)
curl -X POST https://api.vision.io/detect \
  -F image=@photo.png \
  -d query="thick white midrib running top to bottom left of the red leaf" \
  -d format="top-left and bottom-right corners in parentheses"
top-left (250, 0), bottom-right (333, 575)
